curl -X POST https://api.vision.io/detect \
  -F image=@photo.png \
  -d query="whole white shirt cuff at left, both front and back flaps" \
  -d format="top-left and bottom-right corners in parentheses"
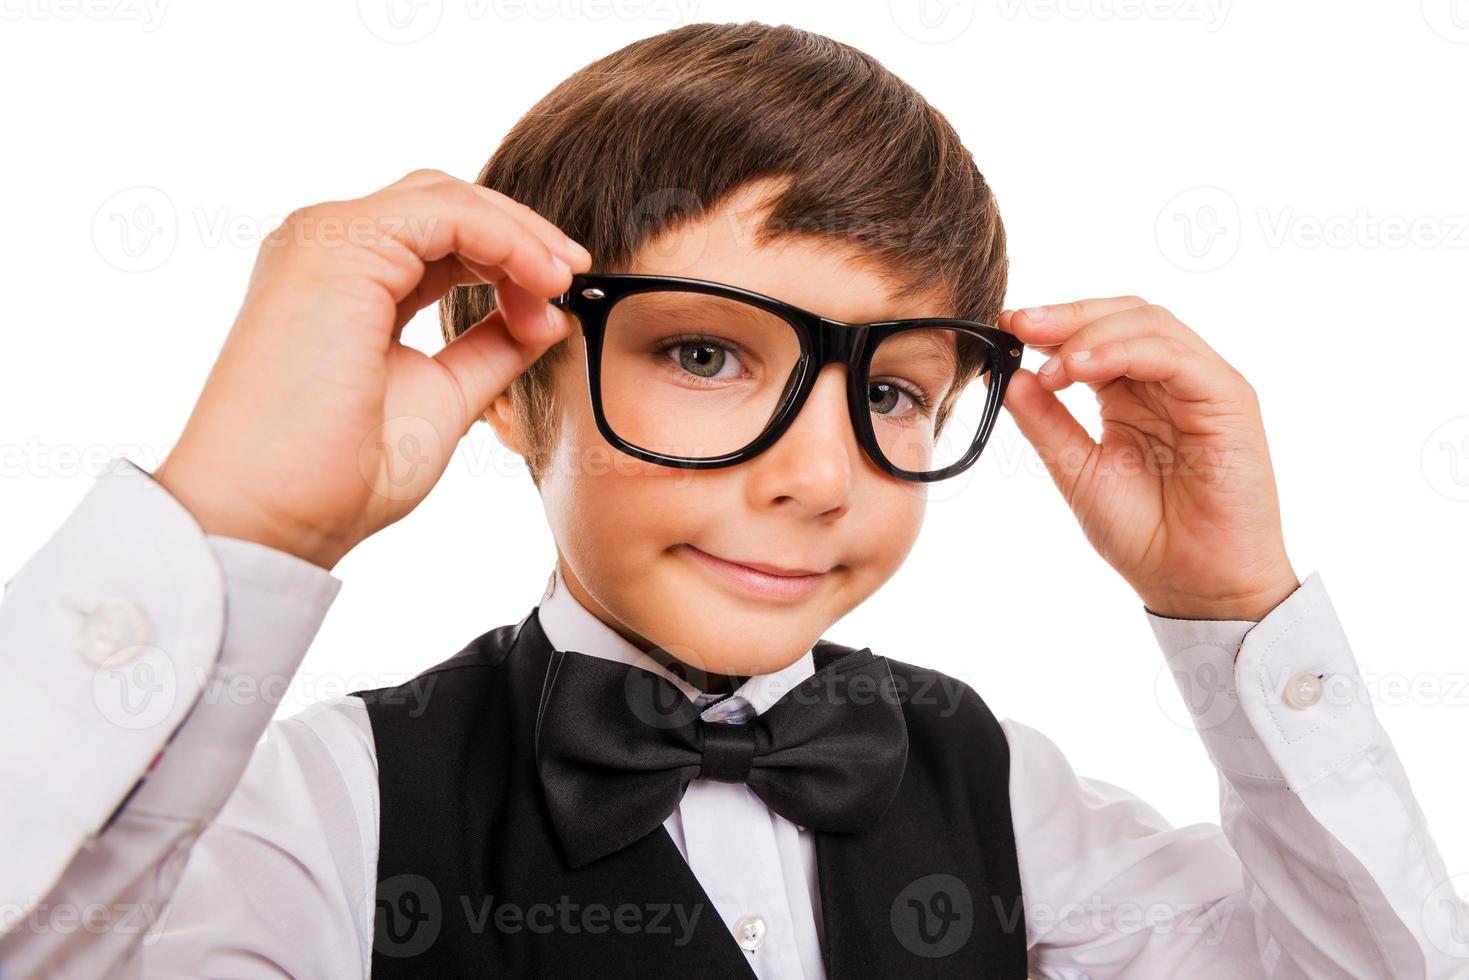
top-left (0, 458), bottom-right (341, 932)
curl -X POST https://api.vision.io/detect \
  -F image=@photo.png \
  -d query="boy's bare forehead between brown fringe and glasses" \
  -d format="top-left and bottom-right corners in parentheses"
top-left (627, 182), bottom-right (948, 323)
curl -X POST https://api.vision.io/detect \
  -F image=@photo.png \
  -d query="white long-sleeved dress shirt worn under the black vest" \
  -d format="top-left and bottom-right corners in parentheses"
top-left (0, 460), bottom-right (1469, 980)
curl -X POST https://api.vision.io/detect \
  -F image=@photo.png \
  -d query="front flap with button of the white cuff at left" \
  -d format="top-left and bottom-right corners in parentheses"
top-left (0, 458), bottom-right (225, 907)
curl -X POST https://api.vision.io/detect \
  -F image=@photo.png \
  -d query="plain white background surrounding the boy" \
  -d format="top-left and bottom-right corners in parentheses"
top-left (0, 0), bottom-right (1469, 910)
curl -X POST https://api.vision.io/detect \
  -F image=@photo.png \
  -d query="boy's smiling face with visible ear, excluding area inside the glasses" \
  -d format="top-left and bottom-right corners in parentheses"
top-left (491, 184), bottom-right (945, 680)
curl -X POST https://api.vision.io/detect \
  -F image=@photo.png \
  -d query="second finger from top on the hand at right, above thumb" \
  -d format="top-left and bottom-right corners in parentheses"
top-left (1043, 336), bottom-right (1243, 403)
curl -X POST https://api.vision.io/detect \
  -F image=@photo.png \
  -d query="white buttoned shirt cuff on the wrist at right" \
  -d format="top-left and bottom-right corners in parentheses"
top-left (1147, 572), bottom-right (1378, 792)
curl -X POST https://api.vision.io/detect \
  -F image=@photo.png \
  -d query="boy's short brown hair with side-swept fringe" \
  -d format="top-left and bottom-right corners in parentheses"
top-left (439, 22), bottom-right (1009, 486)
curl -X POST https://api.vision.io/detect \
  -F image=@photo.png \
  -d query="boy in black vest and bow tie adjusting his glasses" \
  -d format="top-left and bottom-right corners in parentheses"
top-left (0, 17), bottom-right (1465, 977)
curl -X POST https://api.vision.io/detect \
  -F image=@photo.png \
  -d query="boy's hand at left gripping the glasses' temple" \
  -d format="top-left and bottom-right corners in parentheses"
top-left (154, 170), bottom-right (591, 569)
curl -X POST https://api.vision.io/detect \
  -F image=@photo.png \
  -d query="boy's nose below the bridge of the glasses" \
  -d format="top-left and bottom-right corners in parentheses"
top-left (748, 358), bottom-right (862, 517)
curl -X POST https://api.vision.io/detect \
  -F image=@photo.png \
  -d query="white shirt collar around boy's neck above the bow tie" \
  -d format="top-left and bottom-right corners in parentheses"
top-left (538, 563), bottom-right (815, 714)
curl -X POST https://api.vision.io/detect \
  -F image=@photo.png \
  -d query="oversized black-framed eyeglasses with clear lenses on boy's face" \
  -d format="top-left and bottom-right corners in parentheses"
top-left (552, 273), bottom-right (1024, 482)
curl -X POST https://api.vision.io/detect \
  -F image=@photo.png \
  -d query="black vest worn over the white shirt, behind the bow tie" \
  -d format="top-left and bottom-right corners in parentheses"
top-left (354, 610), bottom-right (1027, 980)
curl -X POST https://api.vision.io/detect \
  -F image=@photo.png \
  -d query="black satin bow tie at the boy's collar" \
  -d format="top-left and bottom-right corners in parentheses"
top-left (536, 648), bottom-right (908, 867)
